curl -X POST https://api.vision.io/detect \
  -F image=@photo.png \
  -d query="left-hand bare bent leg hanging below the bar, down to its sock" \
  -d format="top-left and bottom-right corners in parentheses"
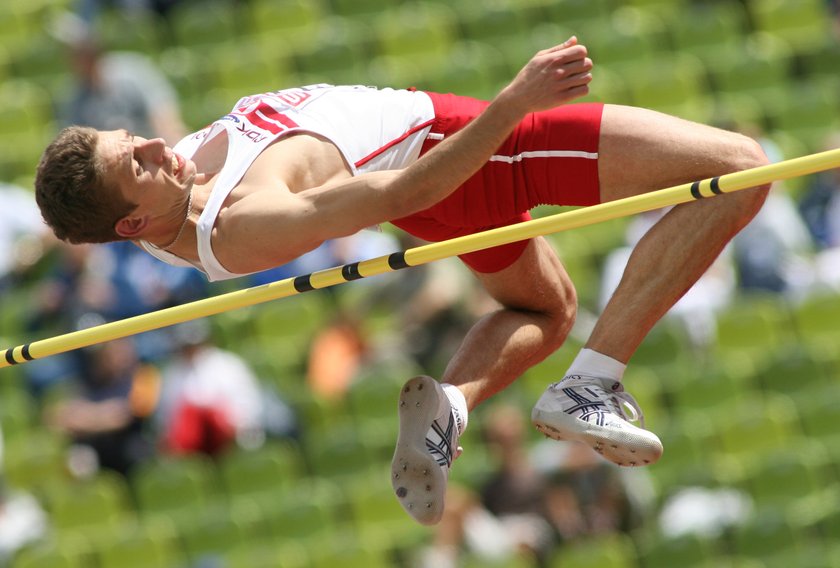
top-left (441, 238), bottom-right (577, 410)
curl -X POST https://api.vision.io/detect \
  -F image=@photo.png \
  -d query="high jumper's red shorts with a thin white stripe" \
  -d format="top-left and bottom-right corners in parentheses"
top-left (392, 93), bottom-right (603, 272)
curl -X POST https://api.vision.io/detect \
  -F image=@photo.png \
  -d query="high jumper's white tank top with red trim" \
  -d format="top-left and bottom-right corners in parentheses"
top-left (140, 85), bottom-right (434, 281)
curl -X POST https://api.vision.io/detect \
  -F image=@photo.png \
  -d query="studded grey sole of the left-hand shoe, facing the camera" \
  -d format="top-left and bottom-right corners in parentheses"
top-left (391, 376), bottom-right (447, 525)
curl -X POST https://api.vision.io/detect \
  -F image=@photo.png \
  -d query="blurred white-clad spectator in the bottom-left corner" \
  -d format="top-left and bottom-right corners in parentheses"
top-left (0, 429), bottom-right (48, 566)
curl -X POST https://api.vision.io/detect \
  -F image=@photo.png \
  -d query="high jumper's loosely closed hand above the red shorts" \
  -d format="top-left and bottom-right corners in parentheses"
top-left (497, 36), bottom-right (592, 114)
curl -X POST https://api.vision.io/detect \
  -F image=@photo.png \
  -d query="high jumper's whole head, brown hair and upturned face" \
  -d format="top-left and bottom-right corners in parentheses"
top-left (35, 126), bottom-right (196, 243)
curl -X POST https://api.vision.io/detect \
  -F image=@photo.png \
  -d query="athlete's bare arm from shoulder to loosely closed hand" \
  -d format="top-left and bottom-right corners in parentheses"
top-left (220, 38), bottom-right (592, 272)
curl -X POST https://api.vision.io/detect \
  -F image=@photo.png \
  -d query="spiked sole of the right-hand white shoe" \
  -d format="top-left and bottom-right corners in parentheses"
top-left (531, 408), bottom-right (662, 467)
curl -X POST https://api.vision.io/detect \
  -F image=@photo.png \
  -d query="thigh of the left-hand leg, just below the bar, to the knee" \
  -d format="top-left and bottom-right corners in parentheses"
top-left (474, 237), bottom-right (577, 313)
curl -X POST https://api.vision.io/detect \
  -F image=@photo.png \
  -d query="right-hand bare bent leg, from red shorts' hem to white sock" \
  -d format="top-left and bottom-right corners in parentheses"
top-left (587, 105), bottom-right (768, 363)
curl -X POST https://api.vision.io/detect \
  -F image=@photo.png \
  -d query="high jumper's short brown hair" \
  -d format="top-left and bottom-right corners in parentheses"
top-left (35, 126), bottom-right (135, 243)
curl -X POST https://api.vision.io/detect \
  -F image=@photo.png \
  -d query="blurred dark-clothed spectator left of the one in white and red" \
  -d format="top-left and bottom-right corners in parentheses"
top-left (46, 339), bottom-right (160, 477)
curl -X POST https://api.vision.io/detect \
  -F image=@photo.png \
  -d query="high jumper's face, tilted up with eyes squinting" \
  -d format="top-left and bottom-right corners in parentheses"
top-left (97, 130), bottom-right (196, 224)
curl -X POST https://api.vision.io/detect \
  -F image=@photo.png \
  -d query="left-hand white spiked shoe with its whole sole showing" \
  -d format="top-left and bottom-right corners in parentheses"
top-left (391, 376), bottom-right (462, 525)
